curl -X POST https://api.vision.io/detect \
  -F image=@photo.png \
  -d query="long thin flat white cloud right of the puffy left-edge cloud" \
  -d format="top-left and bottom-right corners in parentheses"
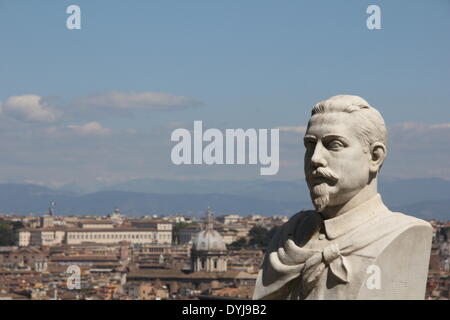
top-left (79, 91), bottom-right (201, 109)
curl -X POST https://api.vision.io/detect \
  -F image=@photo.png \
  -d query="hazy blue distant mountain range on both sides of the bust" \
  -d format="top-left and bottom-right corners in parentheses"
top-left (0, 178), bottom-right (450, 220)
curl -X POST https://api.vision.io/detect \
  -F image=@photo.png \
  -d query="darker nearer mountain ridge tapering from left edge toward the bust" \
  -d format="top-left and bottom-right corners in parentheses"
top-left (0, 184), bottom-right (308, 216)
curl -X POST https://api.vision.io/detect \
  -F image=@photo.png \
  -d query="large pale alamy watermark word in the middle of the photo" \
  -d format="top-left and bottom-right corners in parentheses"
top-left (170, 121), bottom-right (280, 175)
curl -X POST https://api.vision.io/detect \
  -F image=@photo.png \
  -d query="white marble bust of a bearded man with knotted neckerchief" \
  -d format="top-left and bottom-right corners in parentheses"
top-left (253, 95), bottom-right (432, 300)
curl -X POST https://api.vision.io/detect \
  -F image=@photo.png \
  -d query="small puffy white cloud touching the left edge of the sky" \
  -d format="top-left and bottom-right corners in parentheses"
top-left (1, 94), bottom-right (61, 123)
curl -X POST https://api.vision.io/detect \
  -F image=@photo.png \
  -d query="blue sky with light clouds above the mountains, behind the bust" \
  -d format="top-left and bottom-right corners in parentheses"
top-left (0, 0), bottom-right (450, 185)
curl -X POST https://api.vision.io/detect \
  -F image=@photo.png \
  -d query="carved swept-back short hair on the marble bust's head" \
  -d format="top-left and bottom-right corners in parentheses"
top-left (311, 95), bottom-right (387, 146)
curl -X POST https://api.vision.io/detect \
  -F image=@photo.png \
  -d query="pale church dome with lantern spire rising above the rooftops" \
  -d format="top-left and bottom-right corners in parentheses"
top-left (191, 207), bottom-right (227, 272)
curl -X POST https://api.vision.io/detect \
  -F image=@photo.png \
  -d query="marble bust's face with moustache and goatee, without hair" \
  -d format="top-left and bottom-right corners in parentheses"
top-left (304, 112), bottom-right (371, 211)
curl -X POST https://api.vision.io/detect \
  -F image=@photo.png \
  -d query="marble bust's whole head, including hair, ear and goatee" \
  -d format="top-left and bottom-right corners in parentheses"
top-left (304, 95), bottom-right (387, 212)
